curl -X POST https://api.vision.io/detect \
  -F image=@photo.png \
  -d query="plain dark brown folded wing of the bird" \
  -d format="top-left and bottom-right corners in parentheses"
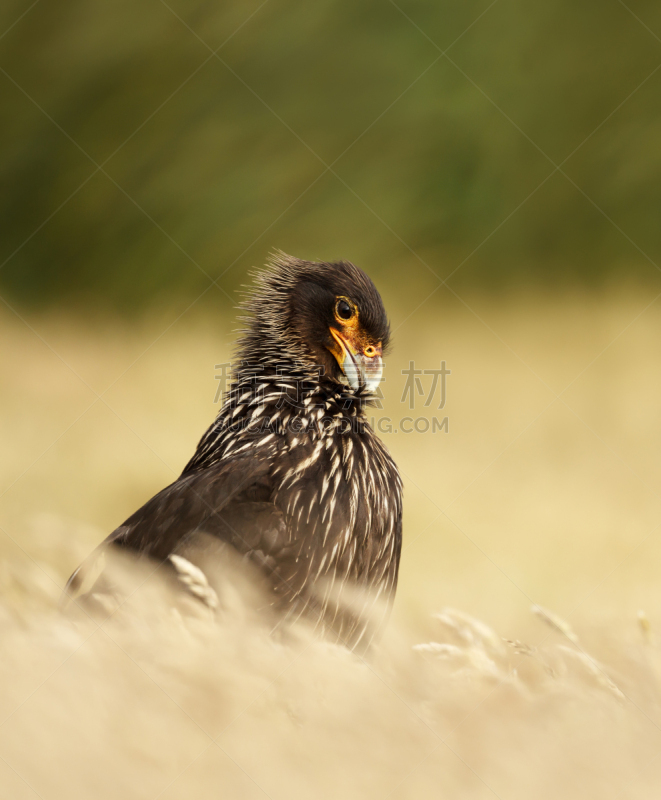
top-left (64, 455), bottom-right (277, 598)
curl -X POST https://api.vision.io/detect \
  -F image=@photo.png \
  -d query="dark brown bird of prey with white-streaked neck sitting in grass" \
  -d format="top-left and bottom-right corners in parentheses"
top-left (65, 251), bottom-right (402, 649)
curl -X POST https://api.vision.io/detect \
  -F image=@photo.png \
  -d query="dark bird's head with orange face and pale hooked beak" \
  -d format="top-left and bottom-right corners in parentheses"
top-left (239, 248), bottom-right (390, 391)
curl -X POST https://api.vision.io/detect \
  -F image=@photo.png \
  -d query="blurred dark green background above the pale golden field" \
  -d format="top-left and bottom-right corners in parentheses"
top-left (0, 0), bottom-right (661, 314)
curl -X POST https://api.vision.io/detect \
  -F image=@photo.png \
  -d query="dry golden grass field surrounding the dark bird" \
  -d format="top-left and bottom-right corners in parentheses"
top-left (0, 292), bottom-right (661, 800)
